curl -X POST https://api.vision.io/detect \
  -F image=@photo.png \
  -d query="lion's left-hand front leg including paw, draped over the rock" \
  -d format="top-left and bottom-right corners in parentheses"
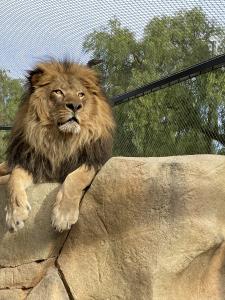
top-left (6, 167), bottom-right (33, 232)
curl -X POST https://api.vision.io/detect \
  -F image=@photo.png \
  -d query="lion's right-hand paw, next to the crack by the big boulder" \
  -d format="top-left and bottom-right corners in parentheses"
top-left (52, 205), bottom-right (79, 232)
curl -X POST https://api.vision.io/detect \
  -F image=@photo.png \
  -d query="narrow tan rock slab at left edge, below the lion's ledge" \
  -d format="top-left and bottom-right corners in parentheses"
top-left (0, 258), bottom-right (55, 289)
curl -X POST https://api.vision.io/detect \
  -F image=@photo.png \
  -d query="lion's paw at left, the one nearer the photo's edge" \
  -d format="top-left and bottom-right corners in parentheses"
top-left (5, 194), bottom-right (31, 232)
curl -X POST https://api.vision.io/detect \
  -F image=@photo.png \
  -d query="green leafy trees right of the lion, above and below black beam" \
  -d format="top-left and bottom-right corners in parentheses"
top-left (84, 8), bottom-right (225, 156)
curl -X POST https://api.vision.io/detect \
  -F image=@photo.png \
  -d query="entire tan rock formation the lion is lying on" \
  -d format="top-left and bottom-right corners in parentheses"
top-left (0, 155), bottom-right (225, 300)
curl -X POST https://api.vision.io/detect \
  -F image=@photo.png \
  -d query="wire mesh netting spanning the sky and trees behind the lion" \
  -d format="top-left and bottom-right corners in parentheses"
top-left (0, 0), bottom-right (225, 159)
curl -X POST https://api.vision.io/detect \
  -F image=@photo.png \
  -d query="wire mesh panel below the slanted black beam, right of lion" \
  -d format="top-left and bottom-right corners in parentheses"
top-left (114, 70), bottom-right (225, 156)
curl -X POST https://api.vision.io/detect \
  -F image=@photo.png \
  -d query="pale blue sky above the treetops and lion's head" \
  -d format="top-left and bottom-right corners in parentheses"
top-left (0, 0), bottom-right (225, 78)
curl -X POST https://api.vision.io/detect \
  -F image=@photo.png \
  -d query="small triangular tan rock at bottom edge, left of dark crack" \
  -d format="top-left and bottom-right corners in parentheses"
top-left (26, 268), bottom-right (69, 300)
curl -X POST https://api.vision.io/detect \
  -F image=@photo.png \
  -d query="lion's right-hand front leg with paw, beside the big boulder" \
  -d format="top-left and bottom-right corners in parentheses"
top-left (52, 165), bottom-right (96, 231)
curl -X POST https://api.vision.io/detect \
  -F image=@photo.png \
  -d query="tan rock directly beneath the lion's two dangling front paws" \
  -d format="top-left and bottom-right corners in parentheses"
top-left (0, 183), bottom-right (66, 266)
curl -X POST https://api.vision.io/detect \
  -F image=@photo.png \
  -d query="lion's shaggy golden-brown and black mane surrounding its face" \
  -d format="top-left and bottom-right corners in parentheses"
top-left (6, 60), bottom-right (114, 182)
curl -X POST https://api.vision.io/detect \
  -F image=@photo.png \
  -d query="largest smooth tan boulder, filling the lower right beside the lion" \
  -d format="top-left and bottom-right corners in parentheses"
top-left (58, 155), bottom-right (225, 300)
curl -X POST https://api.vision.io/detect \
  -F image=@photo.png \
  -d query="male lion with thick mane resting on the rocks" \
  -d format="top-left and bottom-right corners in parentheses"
top-left (0, 59), bottom-right (115, 232)
